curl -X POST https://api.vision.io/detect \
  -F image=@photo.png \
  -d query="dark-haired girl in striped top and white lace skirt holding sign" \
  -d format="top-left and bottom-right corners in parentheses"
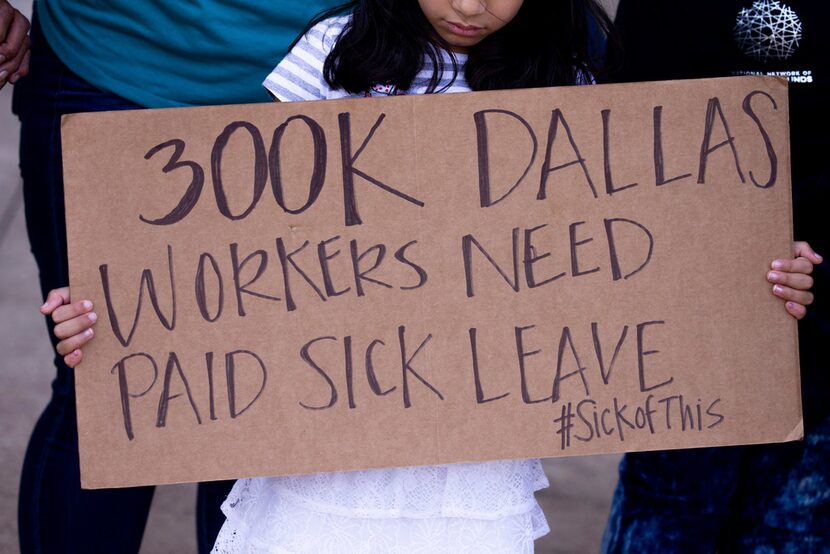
top-left (42, 0), bottom-right (818, 554)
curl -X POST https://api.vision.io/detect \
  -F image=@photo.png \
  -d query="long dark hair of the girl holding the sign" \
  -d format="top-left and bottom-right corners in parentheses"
top-left (295, 0), bottom-right (613, 94)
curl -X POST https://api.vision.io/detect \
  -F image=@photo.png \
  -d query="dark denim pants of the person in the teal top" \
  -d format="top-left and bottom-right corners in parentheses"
top-left (13, 15), bottom-right (232, 554)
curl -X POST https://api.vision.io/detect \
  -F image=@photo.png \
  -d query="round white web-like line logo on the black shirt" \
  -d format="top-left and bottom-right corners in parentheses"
top-left (735, 0), bottom-right (801, 62)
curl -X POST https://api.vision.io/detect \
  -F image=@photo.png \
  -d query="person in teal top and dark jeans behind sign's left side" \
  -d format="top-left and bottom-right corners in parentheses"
top-left (10, 0), bottom-right (342, 554)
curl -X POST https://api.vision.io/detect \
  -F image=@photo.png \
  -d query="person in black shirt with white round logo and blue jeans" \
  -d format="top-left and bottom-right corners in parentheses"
top-left (603, 0), bottom-right (830, 554)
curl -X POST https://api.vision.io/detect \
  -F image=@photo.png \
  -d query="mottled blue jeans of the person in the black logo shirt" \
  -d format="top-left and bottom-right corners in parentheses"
top-left (601, 316), bottom-right (830, 554)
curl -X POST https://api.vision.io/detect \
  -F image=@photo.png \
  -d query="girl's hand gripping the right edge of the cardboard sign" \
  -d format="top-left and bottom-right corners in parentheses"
top-left (767, 241), bottom-right (823, 319)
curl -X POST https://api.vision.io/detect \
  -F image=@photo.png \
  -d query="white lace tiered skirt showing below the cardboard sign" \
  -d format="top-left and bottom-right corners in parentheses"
top-left (213, 460), bottom-right (549, 554)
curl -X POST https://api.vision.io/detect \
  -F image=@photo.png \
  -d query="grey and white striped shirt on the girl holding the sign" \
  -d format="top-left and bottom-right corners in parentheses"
top-left (262, 15), bottom-right (470, 102)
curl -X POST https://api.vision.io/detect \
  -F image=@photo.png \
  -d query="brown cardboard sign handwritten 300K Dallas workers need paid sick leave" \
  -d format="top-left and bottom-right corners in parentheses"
top-left (62, 77), bottom-right (802, 487)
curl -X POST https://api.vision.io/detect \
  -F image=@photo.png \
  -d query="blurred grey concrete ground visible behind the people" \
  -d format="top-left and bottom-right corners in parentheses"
top-left (0, 0), bottom-right (619, 554)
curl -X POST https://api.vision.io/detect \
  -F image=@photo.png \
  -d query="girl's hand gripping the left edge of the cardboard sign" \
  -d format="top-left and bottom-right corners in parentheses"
top-left (40, 287), bottom-right (98, 367)
